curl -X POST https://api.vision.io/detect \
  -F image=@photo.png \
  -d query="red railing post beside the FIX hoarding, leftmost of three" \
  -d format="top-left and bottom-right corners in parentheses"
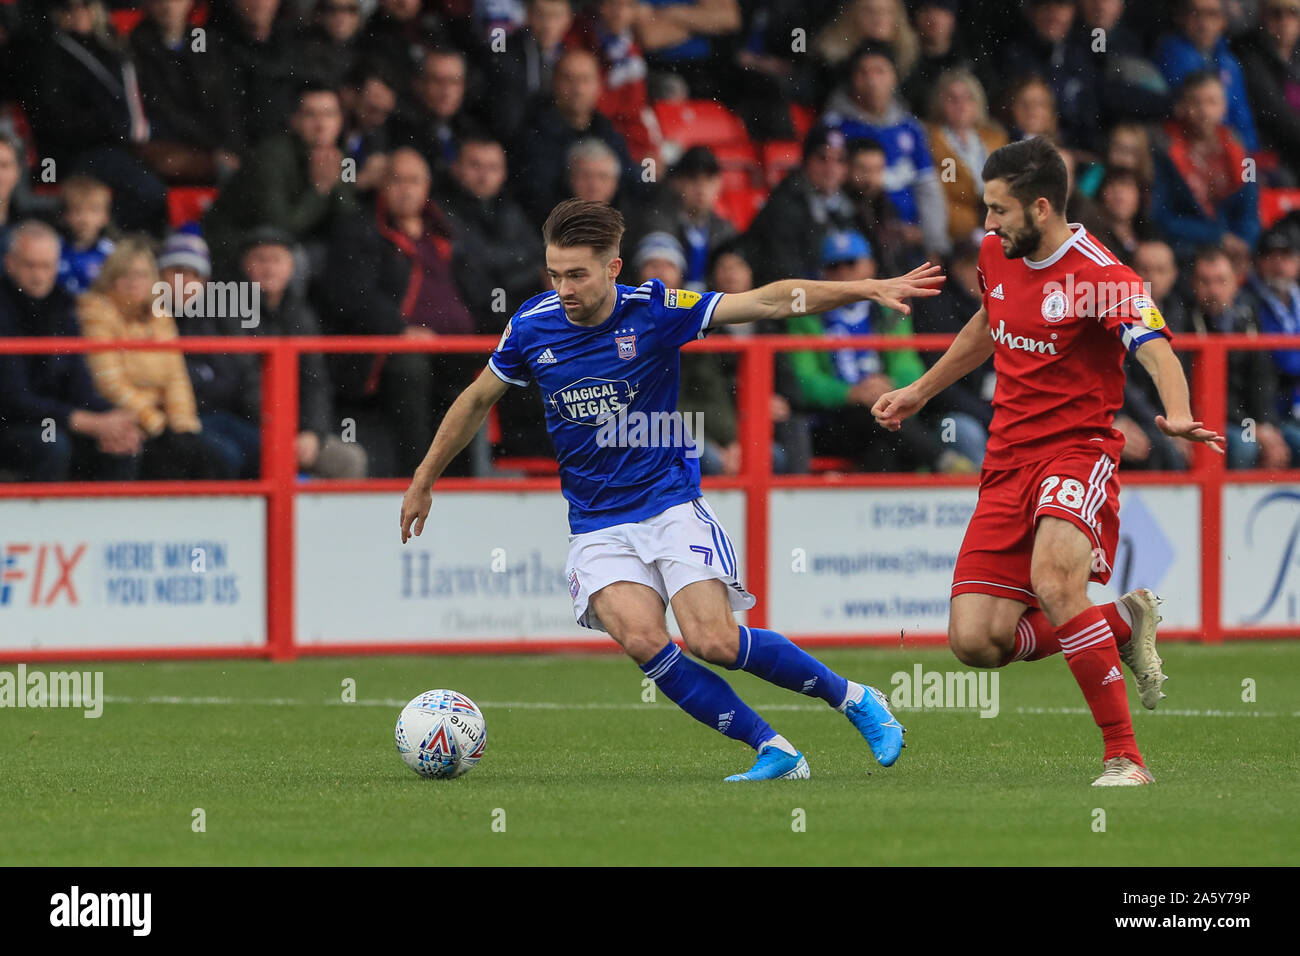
top-left (261, 338), bottom-right (298, 661)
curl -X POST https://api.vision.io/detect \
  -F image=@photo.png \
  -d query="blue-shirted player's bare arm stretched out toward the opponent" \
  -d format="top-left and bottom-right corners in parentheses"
top-left (710, 263), bottom-right (945, 325)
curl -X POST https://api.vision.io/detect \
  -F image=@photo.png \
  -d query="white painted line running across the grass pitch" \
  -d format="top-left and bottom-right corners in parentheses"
top-left (104, 695), bottom-right (1300, 719)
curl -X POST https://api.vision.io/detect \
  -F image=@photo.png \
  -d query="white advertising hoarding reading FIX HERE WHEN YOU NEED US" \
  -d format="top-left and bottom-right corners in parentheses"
top-left (0, 496), bottom-right (267, 652)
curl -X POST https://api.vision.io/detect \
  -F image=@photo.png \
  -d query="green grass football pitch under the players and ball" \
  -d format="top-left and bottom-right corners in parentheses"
top-left (0, 643), bottom-right (1300, 866)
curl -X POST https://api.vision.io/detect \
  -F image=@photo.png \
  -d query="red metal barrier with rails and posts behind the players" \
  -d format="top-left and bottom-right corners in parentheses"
top-left (0, 336), bottom-right (1300, 661)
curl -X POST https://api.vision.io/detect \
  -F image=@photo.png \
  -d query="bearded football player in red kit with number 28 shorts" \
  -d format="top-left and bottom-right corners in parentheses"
top-left (872, 138), bottom-right (1223, 787)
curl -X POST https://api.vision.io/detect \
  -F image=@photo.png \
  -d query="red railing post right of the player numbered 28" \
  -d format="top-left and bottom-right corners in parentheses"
top-left (1193, 339), bottom-right (1242, 644)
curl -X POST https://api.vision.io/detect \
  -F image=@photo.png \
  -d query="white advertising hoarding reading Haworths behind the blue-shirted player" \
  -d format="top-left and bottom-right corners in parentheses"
top-left (295, 490), bottom-right (745, 645)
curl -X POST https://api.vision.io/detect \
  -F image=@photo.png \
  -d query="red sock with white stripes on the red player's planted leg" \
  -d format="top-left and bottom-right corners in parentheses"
top-left (1057, 606), bottom-right (1145, 766)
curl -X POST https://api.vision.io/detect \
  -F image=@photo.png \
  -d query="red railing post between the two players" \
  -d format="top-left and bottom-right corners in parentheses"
top-left (736, 336), bottom-right (776, 627)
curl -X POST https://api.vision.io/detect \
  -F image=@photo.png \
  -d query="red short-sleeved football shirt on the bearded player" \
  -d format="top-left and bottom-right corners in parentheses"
top-left (979, 222), bottom-right (1169, 468)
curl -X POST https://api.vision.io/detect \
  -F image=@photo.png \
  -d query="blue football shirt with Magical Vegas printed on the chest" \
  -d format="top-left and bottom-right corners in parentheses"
top-left (488, 278), bottom-right (722, 535)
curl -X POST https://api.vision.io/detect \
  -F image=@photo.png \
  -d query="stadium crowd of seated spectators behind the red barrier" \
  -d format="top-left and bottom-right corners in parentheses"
top-left (0, 0), bottom-right (1300, 481)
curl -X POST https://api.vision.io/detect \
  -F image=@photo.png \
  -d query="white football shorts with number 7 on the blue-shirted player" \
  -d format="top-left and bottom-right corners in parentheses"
top-left (568, 497), bottom-right (754, 631)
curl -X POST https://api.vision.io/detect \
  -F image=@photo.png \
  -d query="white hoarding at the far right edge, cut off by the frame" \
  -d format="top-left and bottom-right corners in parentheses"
top-left (1222, 484), bottom-right (1300, 630)
